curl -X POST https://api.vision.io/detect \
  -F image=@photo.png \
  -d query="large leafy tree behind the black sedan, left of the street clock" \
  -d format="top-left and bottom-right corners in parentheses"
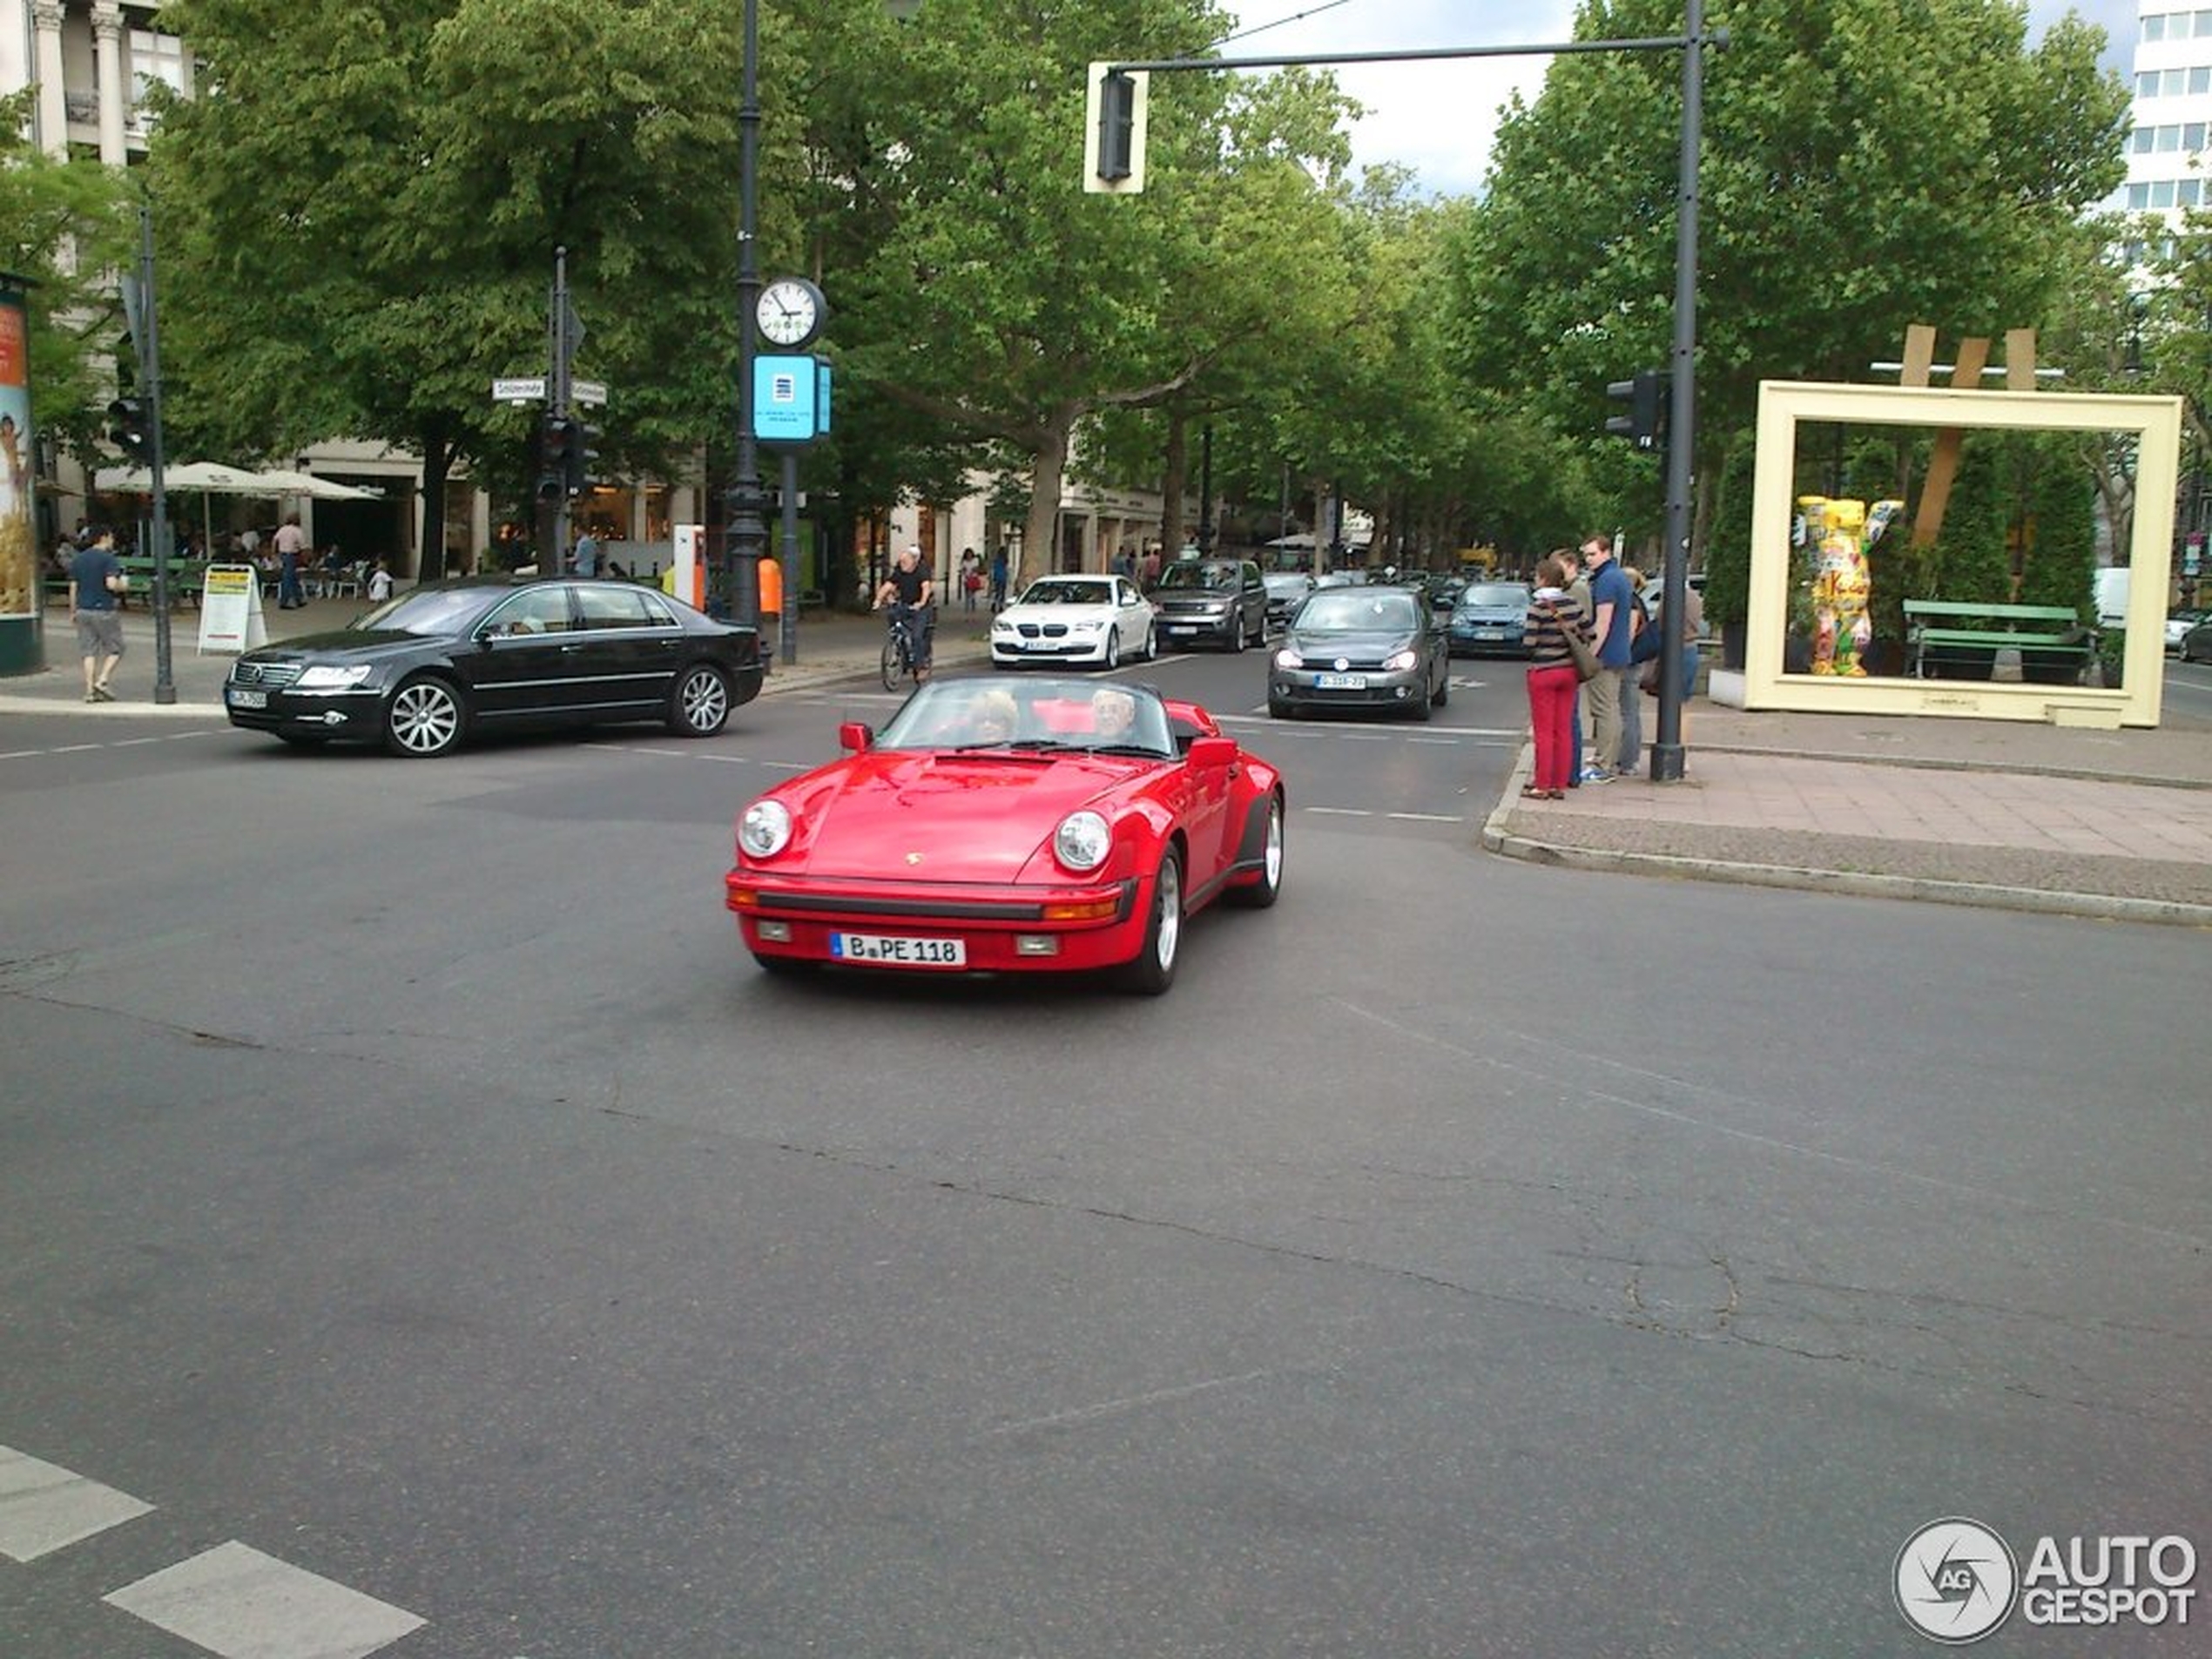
top-left (151, 0), bottom-right (738, 575)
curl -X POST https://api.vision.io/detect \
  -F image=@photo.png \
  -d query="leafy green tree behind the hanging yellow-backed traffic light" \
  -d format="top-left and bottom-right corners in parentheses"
top-left (814, 0), bottom-right (1343, 579)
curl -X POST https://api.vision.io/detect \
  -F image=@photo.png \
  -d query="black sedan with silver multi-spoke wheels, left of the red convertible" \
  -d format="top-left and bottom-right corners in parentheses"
top-left (224, 577), bottom-right (763, 757)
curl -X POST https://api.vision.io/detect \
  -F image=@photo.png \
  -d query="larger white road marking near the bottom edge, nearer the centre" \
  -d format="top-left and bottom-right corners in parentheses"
top-left (102, 1540), bottom-right (422, 1659)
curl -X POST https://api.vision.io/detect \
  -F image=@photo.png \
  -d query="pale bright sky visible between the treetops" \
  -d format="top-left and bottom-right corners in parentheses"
top-left (1221, 0), bottom-right (2137, 195)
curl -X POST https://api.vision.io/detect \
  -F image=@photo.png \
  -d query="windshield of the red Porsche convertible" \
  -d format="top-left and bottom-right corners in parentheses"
top-left (873, 679), bottom-right (1175, 759)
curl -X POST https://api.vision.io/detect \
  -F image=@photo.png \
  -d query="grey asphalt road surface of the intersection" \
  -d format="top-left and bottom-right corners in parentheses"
top-left (0, 652), bottom-right (2212, 1659)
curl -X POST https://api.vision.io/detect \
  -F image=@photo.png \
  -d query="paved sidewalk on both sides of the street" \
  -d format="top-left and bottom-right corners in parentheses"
top-left (0, 599), bottom-right (2212, 927)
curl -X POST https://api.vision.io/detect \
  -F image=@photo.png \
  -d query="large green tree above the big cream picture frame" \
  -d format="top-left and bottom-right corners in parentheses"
top-left (1458, 0), bottom-right (2128, 559)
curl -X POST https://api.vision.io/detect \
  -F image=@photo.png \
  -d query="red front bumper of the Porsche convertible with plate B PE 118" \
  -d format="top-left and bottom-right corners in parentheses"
top-left (724, 865), bottom-right (1150, 974)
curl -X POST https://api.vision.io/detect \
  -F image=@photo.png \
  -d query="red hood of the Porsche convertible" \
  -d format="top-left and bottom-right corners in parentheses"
top-left (767, 752), bottom-right (1162, 882)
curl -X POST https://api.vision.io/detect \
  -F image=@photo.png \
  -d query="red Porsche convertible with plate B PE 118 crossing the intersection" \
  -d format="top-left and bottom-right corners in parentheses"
top-left (725, 677), bottom-right (1283, 995)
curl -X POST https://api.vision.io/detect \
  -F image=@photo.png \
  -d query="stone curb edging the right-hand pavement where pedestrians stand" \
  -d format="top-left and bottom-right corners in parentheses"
top-left (1482, 745), bottom-right (2212, 927)
